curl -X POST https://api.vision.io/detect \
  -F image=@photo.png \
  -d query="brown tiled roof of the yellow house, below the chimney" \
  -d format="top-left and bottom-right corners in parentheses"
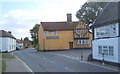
top-left (41, 22), bottom-right (79, 31)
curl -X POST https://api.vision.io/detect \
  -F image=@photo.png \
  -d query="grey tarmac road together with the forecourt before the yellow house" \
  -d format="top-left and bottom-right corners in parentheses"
top-left (11, 49), bottom-right (119, 72)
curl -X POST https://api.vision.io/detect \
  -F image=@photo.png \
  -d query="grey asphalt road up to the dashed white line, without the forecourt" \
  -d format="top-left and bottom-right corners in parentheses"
top-left (14, 48), bottom-right (116, 72)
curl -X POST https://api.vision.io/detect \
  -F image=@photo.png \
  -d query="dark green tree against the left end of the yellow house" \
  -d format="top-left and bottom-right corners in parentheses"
top-left (30, 24), bottom-right (40, 46)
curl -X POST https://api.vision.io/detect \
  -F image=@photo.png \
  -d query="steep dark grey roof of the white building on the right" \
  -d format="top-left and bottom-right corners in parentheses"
top-left (92, 2), bottom-right (120, 28)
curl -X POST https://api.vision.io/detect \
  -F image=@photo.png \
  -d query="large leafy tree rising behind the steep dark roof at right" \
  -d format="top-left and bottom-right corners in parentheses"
top-left (76, 2), bottom-right (108, 26)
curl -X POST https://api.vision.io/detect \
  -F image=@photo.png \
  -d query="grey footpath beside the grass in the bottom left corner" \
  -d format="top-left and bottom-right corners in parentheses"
top-left (1, 53), bottom-right (32, 73)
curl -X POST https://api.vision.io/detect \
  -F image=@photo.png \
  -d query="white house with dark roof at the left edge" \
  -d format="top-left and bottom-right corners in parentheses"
top-left (0, 30), bottom-right (16, 52)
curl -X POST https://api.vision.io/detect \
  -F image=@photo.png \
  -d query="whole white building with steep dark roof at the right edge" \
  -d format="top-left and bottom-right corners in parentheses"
top-left (92, 2), bottom-right (120, 63)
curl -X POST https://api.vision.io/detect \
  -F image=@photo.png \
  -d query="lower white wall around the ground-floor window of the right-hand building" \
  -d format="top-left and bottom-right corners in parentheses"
top-left (92, 37), bottom-right (120, 63)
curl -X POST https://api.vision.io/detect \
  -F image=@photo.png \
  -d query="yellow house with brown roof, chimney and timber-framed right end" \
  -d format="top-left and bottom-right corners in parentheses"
top-left (38, 14), bottom-right (92, 51)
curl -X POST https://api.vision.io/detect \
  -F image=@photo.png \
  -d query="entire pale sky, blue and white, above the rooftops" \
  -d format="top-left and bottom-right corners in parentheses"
top-left (0, 0), bottom-right (87, 39)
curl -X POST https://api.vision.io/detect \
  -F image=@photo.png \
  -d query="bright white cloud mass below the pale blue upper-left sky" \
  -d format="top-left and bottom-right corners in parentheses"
top-left (0, 0), bottom-right (85, 39)
